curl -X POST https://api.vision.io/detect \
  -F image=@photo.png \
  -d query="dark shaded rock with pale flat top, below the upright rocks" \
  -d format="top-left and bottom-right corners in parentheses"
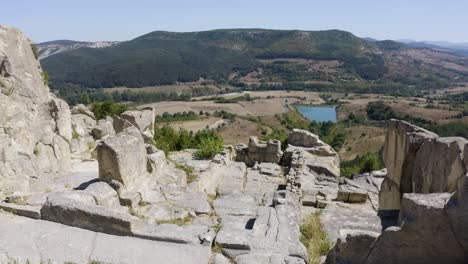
top-left (365, 193), bottom-right (466, 264)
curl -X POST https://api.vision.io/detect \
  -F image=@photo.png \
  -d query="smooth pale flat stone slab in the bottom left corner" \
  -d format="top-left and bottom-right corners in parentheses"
top-left (0, 212), bottom-right (211, 264)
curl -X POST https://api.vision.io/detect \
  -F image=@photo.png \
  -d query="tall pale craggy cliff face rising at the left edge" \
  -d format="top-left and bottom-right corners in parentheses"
top-left (0, 26), bottom-right (71, 192)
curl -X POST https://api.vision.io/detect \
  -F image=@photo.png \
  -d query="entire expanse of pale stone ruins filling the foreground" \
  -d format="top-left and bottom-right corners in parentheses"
top-left (0, 27), bottom-right (468, 264)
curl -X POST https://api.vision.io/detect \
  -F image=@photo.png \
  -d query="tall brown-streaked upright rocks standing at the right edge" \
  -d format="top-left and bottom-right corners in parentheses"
top-left (379, 120), bottom-right (468, 215)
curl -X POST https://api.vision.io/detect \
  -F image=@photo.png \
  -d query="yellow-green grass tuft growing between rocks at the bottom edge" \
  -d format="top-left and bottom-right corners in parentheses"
top-left (300, 213), bottom-right (332, 264)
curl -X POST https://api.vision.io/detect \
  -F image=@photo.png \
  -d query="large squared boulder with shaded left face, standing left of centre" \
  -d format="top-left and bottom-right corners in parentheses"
top-left (97, 127), bottom-right (147, 187)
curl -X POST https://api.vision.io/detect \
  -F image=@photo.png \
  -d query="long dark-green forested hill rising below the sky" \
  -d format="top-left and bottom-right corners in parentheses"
top-left (41, 29), bottom-right (468, 96)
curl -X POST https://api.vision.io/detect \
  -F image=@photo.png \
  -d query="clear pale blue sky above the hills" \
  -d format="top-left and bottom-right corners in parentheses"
top-left (0, 0), bottom-right (468, 42)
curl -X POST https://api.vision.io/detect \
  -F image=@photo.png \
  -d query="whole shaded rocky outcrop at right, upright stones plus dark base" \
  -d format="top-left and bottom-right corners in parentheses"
top-left (327, 120), bottom-right (468, 264)
